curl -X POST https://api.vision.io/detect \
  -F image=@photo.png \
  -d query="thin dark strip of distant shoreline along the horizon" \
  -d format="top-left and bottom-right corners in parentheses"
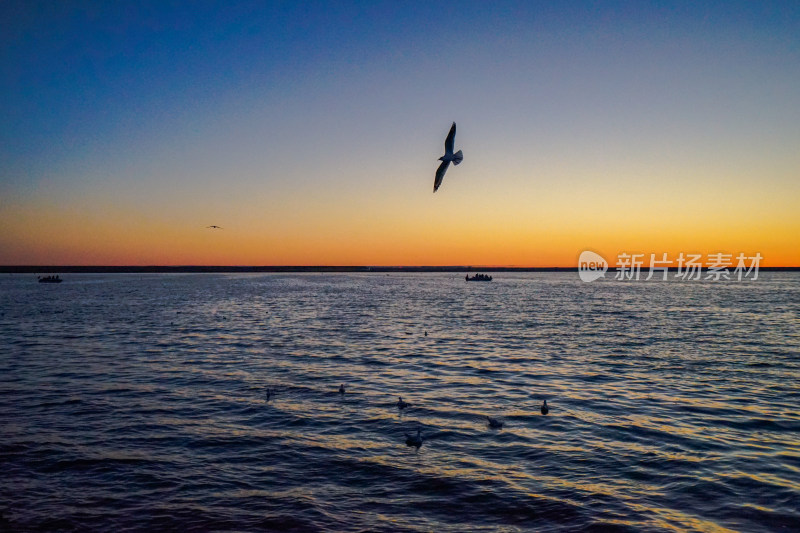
top-left (0, 265), bottom-right (800, 274)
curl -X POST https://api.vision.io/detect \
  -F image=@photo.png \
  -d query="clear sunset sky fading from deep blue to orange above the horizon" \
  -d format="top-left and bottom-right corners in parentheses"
top-left (0, 0), bottom-right (800, 267)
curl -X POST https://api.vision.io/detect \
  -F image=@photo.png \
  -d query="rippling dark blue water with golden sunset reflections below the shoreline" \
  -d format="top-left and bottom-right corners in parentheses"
top-left (0, 272), bottom-right (800, 532)
